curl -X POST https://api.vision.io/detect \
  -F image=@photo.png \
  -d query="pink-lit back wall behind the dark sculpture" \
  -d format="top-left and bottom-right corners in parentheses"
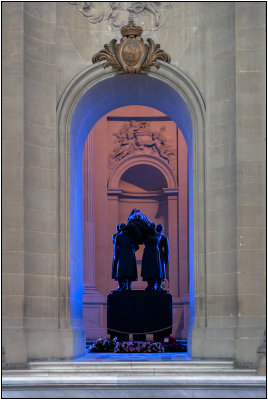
top-left (83, 106), bottom-right (189, 338)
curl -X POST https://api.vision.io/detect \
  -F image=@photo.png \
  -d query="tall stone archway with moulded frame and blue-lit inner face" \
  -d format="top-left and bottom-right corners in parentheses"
top-left (58, 63), bottom-right (206, 356)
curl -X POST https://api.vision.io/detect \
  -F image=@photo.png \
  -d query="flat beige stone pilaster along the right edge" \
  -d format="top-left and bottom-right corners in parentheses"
top-left (235, 2), bottom-right (266, 366)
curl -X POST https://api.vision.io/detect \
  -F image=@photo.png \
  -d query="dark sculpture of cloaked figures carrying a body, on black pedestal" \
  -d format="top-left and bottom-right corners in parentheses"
top-left (112, 208), bottom-right (169, 291)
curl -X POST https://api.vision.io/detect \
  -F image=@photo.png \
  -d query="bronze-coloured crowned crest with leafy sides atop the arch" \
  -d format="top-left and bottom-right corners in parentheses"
top-left (92, 19), bottom-right (170, 74)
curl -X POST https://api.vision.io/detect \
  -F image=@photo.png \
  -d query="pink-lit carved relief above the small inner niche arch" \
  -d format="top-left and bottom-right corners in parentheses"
top-left (110, 120), bottom-right (175, 166)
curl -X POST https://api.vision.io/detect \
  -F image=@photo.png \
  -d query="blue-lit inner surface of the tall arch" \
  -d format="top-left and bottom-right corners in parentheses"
top-left (70, 74), bottom-right (194, 354)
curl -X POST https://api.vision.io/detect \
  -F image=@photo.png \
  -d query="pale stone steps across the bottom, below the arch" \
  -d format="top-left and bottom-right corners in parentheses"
top-left (2, 357), bottom-right (266, 399)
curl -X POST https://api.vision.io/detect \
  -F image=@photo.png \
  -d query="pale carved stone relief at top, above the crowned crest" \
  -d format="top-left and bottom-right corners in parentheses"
top-left (69, 1), bottom-right (174, 31)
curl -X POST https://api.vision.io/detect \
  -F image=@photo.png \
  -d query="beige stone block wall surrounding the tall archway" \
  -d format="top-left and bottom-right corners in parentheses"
top-left (3, 2), bottom-right (266, 364)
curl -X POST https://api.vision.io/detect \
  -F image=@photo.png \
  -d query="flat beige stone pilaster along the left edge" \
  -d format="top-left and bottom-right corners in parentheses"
top-left (2, 2), bottom-right (27, 365)
